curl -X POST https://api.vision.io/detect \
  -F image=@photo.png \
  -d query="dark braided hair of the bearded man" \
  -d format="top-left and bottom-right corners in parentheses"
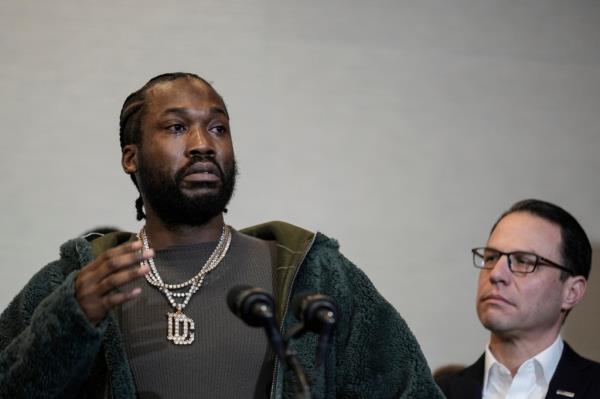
top-left (119, 72), bottom-right (229, 220)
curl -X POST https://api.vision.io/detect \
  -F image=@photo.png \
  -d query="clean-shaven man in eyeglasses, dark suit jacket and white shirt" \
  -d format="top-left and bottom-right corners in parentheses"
top-left (438, 200), bottom-right (600, 399)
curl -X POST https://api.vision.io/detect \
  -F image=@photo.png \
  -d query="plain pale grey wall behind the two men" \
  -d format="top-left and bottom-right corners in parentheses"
top-left (0, 0), bottom-right (600, 368)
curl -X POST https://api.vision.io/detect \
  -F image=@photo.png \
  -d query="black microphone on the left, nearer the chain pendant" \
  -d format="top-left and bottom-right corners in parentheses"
top-left (227, 285), bottom-right (286, 362)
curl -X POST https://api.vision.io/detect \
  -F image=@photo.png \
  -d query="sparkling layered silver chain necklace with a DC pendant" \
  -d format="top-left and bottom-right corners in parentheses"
top-left (138, 224), bottom-right (231, 345)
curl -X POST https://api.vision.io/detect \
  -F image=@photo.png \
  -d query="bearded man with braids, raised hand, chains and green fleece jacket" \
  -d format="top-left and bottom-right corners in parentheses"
top-left (0, 73), bottom-right (441, 399)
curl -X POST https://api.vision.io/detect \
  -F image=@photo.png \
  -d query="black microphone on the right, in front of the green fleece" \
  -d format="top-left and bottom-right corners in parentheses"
top-left (293, 293), bottom-right (338, 366)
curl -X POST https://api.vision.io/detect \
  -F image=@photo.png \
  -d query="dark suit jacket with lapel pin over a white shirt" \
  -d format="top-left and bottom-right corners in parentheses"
top-left (437, 342), bottom-right (600, 399)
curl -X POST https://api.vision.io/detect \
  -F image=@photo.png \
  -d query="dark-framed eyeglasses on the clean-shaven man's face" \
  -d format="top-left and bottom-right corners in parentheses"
top-left (471, 247), bottom-right (575, 275)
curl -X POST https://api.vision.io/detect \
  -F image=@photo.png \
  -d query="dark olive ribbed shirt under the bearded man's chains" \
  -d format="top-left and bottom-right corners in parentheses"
top-left (120, 230), bottom-right (275, 399)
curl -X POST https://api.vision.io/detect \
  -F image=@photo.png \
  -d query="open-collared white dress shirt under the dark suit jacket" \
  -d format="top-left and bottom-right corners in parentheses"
top-left (483, 336), bottom-right (564, 399)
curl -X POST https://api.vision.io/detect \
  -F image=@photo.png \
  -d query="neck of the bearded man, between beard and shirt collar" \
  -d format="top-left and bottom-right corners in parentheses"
top-left (145, 212), bottom-right (224, 250)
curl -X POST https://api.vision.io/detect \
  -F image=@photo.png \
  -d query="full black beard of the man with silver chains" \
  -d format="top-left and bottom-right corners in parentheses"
top-left (138, 152), bottom-right (238, 226)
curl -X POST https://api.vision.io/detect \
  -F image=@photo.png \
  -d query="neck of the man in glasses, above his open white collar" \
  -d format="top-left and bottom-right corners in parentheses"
top-left (490, 330), bottom-right (559, 377)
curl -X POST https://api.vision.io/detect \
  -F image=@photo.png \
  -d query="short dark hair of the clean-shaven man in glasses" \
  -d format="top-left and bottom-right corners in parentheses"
top-left (490, 199), bottom-right (592, 280)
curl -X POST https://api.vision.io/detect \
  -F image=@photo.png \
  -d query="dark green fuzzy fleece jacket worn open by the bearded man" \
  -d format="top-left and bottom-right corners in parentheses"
top-left (0, 222), bottom-right (443, 399)
